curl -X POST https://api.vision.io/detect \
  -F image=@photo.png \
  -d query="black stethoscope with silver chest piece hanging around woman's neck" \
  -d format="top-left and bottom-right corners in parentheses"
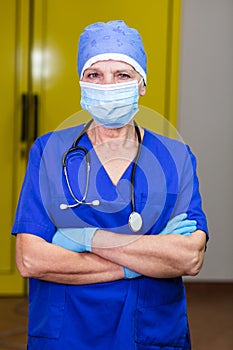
top-left (60, 120), bottom-right (142, 232)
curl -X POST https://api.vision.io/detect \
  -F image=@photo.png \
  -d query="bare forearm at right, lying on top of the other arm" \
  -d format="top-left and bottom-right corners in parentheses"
top-left (92, 230), bottom-right (206, 278)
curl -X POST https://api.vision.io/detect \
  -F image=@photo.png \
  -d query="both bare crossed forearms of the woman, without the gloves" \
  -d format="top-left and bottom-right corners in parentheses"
top-left (16, 219), bottom-right (206, 284)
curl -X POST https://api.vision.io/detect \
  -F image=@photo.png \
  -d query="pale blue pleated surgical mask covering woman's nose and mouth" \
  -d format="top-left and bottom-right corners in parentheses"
top-left (80, 80), bottom-right (140, 128)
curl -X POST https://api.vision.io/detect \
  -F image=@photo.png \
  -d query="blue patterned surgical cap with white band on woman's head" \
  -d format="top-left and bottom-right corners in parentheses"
top-left (78, 21), bottom-right (147, 83)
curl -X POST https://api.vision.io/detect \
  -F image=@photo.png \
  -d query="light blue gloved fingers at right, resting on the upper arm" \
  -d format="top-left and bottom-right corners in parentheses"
top-left (159, 213), bottom-right (197, 236)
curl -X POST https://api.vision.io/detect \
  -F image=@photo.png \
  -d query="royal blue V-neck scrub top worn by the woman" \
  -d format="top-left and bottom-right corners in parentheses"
top-left (12, 126), bottom-right (208, 350)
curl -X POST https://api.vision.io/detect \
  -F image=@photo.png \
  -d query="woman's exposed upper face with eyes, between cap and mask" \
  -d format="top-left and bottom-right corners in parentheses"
top-left (82, 60), bottom-right (146, 96)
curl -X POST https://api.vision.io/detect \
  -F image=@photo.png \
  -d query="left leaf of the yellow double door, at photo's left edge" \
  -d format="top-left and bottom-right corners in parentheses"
top-left (0, 0), bottom-right (28, 295)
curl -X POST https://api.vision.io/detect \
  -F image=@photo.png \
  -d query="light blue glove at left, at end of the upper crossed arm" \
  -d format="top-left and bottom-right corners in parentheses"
top-left (52, 227), bottom-right (98, 253)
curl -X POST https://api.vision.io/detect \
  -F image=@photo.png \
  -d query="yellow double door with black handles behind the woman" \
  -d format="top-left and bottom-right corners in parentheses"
top-left (0, 0), bottom-right (181, 295)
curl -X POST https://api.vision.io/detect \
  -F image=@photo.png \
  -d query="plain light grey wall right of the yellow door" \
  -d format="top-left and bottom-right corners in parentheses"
top-left (178, 0), bottom-right (233, 281)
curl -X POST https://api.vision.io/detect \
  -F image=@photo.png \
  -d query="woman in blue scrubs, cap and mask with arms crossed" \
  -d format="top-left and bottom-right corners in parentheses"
top-left (12, 21), bottom-right (208, 350)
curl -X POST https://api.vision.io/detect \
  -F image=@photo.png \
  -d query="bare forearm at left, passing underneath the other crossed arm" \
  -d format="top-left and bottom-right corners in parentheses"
top-left (16, 233), bottom-right (124, 285)
